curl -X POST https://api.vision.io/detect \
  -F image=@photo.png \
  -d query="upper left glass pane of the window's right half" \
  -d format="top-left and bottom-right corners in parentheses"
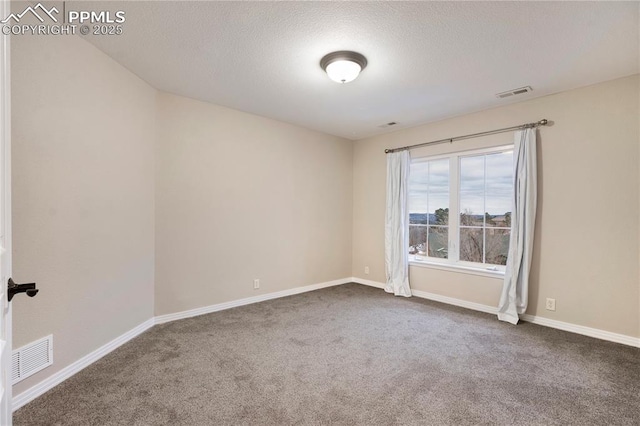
top-left (460, 155), bottom-right (484, 226)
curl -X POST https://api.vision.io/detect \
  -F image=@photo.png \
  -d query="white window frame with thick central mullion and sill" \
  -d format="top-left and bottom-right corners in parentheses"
top-left (409, 144), bottom-right (513, 278)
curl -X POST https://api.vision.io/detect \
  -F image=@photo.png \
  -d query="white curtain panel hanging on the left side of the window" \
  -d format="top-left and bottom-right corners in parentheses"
top-left (384, 151), bottom-right (411, 297)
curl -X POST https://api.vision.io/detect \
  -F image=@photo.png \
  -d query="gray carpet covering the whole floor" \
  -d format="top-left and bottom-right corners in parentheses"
top-left (14, 284), bottom-right (640, 425)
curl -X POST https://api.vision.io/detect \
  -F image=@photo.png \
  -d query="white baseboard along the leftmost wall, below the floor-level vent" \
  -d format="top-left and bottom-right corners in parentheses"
top-left (11, 318), bottom-right (154, 411)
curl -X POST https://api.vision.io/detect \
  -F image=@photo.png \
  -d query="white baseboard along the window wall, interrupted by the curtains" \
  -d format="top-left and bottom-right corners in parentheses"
top-left (351, 277), bottom-right (640, 348)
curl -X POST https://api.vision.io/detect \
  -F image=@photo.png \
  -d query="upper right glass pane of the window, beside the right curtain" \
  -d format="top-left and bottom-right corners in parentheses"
top-left (485, 151), bottom-right (513, 227)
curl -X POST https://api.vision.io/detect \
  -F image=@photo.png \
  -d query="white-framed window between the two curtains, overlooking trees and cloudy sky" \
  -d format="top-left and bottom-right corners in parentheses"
top-left (409, 146), bottom-right (513, 270)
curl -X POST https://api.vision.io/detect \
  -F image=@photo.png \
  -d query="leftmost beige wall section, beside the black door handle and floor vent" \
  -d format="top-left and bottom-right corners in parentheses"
top-left (11, 36), bottom-right (156, 394)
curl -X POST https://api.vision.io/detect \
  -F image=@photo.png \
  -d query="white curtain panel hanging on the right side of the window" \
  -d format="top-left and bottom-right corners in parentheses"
top-left (498, 129), bottom-right (538, 324)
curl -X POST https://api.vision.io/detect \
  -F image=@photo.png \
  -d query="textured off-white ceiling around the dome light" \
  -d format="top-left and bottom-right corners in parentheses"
top-left (81, 1), bottom-right (640, 139)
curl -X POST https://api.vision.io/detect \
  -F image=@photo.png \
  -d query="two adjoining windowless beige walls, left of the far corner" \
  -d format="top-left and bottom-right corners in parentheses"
top-left (12, 37), bottom-right (352, 400)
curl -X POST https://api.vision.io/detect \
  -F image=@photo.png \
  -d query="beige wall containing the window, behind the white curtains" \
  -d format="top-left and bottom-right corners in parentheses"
top-left (353, 75), bottom-right (640, 337)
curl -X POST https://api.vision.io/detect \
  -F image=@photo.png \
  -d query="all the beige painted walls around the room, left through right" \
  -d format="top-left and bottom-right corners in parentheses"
top-left (6, 30), bottom-right (640, 402)
